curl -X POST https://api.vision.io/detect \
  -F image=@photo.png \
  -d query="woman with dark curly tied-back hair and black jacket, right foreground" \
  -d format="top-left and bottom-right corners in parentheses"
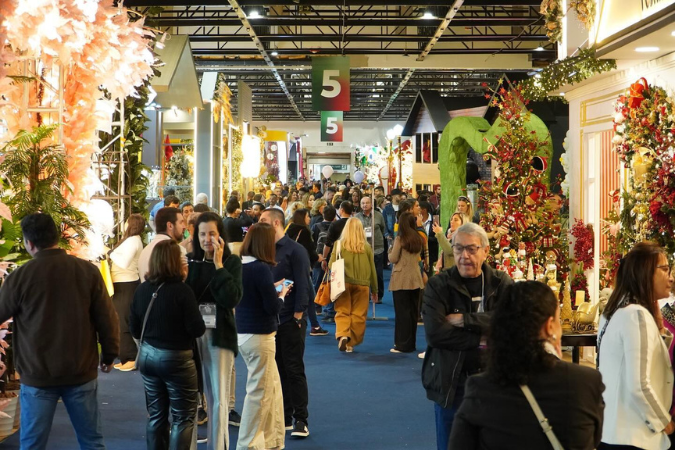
top-left (449, 281), bottom-right (604, 450)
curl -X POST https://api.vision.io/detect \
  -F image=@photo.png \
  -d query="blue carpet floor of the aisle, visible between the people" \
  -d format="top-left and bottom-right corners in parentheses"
top-left (0, 272), bottom-right (435, 450)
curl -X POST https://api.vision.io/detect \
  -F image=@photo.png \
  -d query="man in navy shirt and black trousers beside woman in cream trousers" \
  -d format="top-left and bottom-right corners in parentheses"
top-left (260, 208), bottom-right (313, 438)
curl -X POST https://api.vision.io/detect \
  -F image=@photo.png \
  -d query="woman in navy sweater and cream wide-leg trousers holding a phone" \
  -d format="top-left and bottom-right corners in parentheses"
top-left (235, 223), bottom-right (289, 450)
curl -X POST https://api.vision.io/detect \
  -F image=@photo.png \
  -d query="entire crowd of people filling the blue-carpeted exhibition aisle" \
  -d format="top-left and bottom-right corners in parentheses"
top-left (0, 180), bottom-right (675, 450)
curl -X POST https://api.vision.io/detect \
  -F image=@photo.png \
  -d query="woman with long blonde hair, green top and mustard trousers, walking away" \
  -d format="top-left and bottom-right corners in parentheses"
top-left (329, 217), bottom-right (377, 353)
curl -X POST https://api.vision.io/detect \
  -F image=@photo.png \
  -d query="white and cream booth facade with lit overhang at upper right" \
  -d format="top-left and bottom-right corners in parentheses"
top-left (561, 0), bottom-right (675, 301)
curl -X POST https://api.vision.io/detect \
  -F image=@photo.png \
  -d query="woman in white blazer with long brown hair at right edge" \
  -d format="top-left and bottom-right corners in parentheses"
top-left (598, 242), bottom-right (675, 450)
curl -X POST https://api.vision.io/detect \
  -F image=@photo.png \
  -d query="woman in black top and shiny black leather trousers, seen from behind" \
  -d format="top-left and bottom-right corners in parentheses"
top-left (129, 239), bottom-right (206, 450)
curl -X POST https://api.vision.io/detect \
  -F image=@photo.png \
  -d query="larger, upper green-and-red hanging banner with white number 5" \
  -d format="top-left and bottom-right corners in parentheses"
top-left (312, 56), bottom-right (350, 111)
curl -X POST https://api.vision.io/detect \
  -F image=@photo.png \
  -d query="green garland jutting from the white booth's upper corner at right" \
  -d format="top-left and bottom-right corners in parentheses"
top-left (519, 48), bottom-right (616, 101)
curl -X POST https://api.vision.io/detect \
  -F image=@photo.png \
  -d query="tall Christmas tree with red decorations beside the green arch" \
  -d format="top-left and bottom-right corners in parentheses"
top-left (480, 85), bottom-right (568, 284)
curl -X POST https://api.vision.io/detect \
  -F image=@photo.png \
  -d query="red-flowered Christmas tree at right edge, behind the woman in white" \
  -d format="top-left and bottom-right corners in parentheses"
top-left (601, 78), bottom-right (675, 270)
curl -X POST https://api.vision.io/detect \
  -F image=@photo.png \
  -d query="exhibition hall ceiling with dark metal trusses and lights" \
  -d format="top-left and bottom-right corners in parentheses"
top-left (124, 0), bottom-right (556, 120)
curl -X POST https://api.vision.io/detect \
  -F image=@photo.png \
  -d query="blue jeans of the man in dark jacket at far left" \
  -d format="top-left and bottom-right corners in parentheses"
top-left (21, 380), bottom-right (105, 450)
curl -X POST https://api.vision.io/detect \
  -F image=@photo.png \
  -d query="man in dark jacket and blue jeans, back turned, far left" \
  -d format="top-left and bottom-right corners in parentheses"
top-left (0, 214), bottom-right (120, 449)
